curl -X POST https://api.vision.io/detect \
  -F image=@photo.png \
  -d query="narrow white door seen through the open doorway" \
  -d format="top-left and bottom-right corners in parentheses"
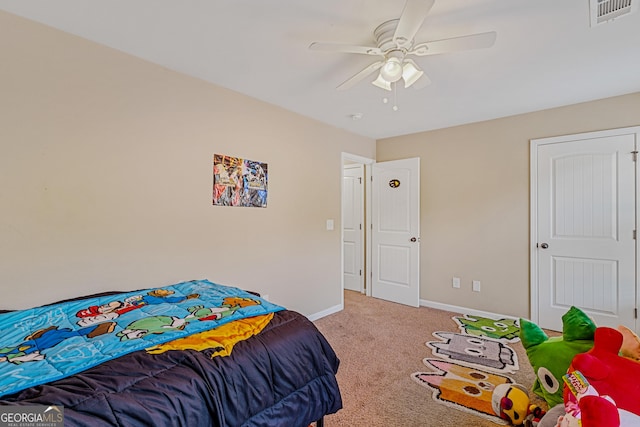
top-left (342, 164), bottom-right (364, 292)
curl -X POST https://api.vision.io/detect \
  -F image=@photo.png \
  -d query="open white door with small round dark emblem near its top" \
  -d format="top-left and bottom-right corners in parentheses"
top-left (371, 158), bottom-right (420, 307)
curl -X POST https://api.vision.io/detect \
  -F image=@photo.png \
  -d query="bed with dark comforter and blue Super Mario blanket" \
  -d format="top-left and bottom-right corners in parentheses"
top-left (0, 281), bottom-right (342, 427)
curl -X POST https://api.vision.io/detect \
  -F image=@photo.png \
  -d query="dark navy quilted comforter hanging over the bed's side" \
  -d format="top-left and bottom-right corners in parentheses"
top-left (0, 310), bottom-right (342, 427)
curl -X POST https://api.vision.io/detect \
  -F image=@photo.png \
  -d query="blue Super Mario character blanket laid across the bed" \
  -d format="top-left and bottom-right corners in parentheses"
top-left (0, 280), bottom-right (284, 396)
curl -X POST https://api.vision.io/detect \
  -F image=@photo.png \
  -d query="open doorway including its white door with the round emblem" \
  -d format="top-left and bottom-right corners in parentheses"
top-left (341, 153), bottom-right (420, 307)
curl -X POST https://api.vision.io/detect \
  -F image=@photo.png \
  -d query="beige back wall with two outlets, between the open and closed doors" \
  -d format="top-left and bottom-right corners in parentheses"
top-left (377, 93), bottom-right (640, 317)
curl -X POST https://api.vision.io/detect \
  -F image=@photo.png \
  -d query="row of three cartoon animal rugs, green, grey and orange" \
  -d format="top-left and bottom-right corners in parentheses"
top-left (411, 315), bottom-right (520, 425)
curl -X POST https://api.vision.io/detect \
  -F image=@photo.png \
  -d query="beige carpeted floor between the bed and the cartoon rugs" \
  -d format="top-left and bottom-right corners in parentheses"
top-left (314, 291), bottom-right (544, 427)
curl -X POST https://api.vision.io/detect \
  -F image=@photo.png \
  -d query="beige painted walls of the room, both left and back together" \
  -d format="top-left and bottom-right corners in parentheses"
top-left (0, 12), bottom-right (640, 316)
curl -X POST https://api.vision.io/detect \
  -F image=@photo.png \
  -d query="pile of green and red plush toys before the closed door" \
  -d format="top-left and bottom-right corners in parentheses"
top-left (516, 307), bottom-right (640, 427)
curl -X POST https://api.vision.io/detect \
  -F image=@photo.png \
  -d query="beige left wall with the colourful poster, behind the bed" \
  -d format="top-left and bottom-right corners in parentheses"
top-left (0, 12), bottom-right (375, 315)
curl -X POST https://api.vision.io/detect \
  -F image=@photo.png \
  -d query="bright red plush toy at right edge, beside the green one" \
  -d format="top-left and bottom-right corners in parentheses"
top-left (564, 327), bottom-right (640, 427)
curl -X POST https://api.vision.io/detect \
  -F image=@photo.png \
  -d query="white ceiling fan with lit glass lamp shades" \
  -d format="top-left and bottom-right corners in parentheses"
top-left (309, 0), bottom-right (496, 90)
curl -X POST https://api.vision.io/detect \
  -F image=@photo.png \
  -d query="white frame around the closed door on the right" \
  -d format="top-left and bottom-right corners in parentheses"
top-left (529, 126), bottom-right (640, 325)
